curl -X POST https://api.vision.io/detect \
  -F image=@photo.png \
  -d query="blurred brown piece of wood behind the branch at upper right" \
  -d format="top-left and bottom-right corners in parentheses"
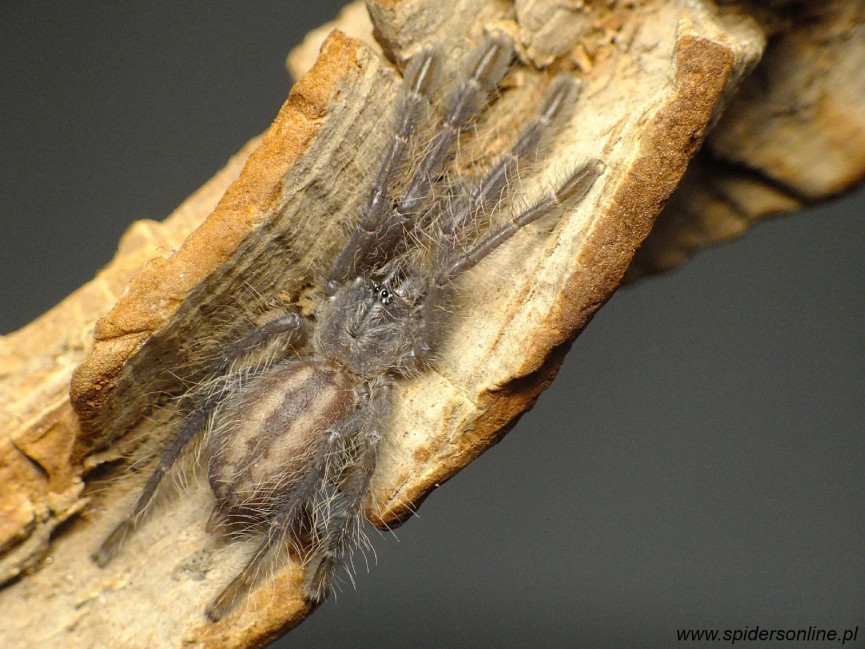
top-left (628, 0), bottom-right (865, 281)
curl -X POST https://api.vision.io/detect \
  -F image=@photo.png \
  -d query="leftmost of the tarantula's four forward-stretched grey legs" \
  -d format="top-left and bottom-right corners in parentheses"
top-left (325, 49), bottom-right (439, 295)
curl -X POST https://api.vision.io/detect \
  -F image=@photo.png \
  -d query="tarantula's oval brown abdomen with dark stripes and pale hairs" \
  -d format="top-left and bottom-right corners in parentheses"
top-left (207, 360), bottom-right (358, 521)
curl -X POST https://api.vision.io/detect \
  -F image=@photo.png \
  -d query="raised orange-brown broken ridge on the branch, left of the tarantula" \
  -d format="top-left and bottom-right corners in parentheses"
top-left (70, 37), bottom-right (358, 450)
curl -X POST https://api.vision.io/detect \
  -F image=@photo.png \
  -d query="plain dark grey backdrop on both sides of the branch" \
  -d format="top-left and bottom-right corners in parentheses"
top-left (0, 1), bottom-right (865, 647)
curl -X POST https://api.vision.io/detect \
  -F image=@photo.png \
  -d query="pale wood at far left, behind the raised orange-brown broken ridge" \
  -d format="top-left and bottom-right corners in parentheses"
top-left (0, 138), bottom-right (258, 584)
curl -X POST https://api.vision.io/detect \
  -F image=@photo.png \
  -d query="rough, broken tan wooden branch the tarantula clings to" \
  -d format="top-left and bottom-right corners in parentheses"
top-left (0, 0), bottom-right (865, 647)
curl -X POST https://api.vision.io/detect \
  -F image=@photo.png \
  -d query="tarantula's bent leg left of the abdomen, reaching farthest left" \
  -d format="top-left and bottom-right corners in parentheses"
top-left (92, 312), bottom-right (307, 568)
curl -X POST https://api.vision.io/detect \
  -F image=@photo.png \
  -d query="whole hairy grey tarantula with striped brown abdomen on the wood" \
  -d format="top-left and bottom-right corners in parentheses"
top-left (93, 36), bottom-right (603, 621)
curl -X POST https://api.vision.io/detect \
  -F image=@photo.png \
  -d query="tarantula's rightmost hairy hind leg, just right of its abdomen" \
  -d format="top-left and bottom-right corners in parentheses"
top-left (304, 381), bottom-right (392, 603)
